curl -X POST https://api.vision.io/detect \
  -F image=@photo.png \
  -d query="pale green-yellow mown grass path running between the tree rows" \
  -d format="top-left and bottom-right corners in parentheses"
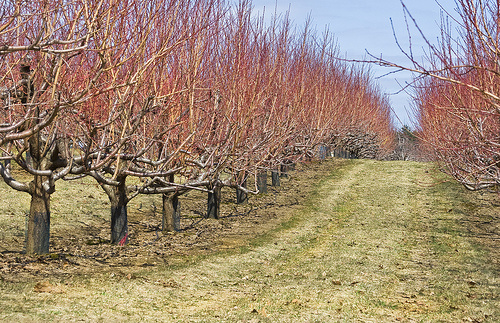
top-left (0, 161), bottom-right (500, 322)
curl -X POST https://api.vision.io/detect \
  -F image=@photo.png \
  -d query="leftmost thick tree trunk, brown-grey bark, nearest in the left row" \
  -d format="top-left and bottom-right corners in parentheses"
top-left (26, 176), bottom-right (50, 255)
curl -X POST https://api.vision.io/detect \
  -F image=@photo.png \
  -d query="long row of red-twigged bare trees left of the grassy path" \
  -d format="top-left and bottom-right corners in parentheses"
top-left (0, 0), bottom-right (393, 254)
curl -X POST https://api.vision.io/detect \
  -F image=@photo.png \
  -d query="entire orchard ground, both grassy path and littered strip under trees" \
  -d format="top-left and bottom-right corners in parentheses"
top-left (0, 159), bottom-right (500, 323)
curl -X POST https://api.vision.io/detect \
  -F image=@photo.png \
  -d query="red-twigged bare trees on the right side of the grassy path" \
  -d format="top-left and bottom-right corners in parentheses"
top-left (370, 0), bottom-right (500, 190)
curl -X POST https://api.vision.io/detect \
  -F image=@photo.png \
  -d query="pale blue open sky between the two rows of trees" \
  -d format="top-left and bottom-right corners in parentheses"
top-left (252, 0), bottom-right (456, 128)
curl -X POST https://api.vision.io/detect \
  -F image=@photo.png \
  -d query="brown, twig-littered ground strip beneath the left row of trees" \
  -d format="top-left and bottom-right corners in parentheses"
top-left (0, 160), bottom-right (342, 282)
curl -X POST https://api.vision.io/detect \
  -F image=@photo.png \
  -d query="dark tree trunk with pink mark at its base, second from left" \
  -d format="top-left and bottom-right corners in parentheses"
top-left (106, 180), bottom-right (128, 246)
